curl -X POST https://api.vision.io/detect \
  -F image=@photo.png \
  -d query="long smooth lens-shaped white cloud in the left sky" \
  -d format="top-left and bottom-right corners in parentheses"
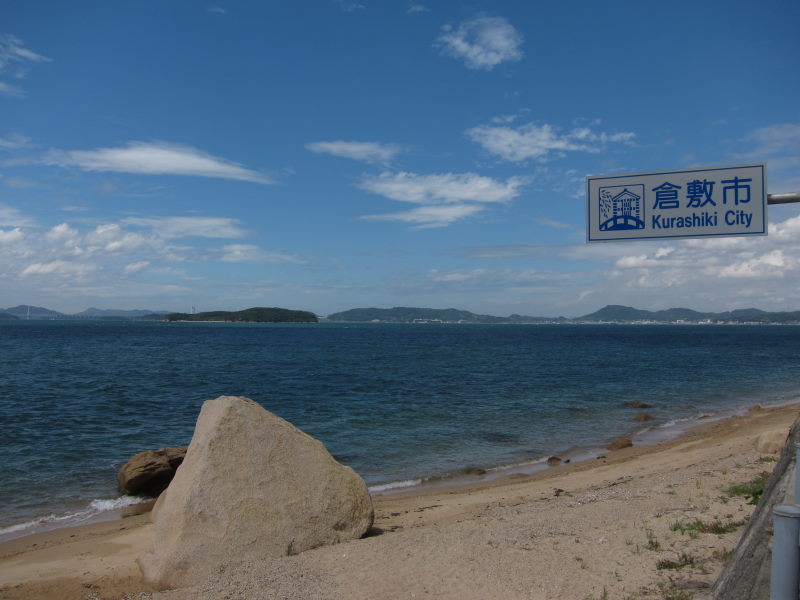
top-left (45, 142), bottom-right (273, 184)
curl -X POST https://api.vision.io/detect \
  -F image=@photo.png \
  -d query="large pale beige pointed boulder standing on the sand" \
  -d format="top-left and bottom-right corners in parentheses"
top-left (138, 396), bottom-right (373, 589)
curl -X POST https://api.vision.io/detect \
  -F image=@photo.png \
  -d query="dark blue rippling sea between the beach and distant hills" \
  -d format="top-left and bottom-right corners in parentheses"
top-left (0, 321), bottom-right (800, 535)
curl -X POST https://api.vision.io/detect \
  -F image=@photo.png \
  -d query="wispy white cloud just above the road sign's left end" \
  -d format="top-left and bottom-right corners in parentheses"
top-left (466, 123), bottom-right (635, 162)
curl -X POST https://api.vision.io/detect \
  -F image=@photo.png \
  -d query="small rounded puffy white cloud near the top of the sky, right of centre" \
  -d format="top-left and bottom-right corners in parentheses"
top-left (437, 17), bottom-right (523, 71)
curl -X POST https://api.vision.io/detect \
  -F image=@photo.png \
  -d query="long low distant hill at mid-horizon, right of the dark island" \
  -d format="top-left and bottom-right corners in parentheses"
top-left (328, 306), bottom-right (566, 323)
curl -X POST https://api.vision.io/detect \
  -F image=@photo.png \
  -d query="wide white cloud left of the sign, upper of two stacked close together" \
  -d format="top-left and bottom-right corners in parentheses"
top-left (357, 172), bottom-right (527, 204)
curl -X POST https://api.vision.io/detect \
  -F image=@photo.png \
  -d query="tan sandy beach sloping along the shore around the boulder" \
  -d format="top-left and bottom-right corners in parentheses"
top-left (0, 405), bottom-right (800, 600)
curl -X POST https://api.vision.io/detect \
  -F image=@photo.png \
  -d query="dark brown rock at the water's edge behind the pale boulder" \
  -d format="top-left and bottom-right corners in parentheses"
top-left (117, 446), bottom-right (186, 497)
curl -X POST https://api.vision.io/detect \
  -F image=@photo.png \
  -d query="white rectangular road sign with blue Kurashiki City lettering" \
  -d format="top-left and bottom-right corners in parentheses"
top-left (586, 163), bottom-right (767, 242)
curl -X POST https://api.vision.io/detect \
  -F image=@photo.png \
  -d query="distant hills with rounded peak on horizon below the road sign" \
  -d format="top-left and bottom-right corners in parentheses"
top-left (572, 304), bottom-right (800, 323)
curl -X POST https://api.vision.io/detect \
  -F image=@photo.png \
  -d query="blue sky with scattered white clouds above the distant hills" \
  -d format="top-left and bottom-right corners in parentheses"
top-left (0, 0), bottom-right (800, 316)
